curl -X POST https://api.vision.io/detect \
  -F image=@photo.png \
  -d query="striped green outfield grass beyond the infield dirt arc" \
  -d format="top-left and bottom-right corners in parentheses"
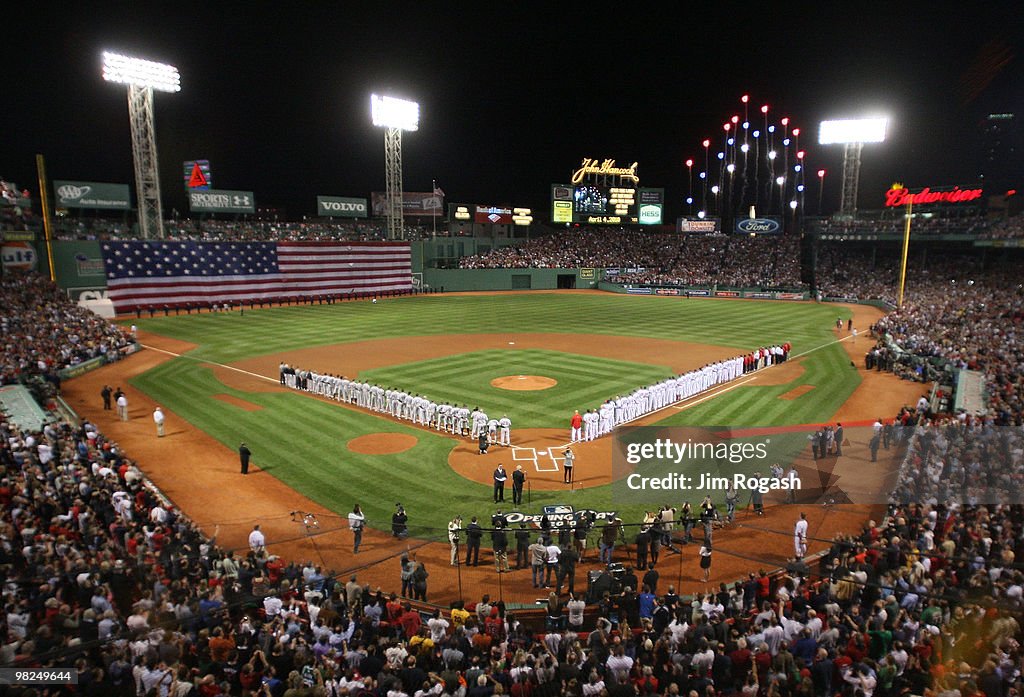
top-left (128, 292), bottom-right (849, 362)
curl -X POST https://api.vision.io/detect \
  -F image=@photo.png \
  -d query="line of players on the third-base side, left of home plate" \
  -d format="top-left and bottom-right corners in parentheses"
top-left (279, 363), bottom-right (512, 446)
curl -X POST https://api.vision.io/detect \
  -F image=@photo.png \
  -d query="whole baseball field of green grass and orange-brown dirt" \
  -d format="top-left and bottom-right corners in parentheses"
top-left (64, 292), bottom-right (920, 601)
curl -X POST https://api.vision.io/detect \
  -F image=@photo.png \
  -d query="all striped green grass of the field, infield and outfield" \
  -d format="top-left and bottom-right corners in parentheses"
top-left (125, 293), bottom-right (859, 538)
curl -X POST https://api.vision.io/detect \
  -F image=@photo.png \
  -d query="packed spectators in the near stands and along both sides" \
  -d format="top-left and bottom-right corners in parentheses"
top-left (0, 259), bottom-right (1024, 697)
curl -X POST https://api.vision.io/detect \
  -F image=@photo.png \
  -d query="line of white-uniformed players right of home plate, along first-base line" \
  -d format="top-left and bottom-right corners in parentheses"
top-left (569, 342), bottom-right (792, 443)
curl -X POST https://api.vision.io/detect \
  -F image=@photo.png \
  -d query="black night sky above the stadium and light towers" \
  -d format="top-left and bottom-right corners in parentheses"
top-left (0, 1), bottom-right (1024, 219)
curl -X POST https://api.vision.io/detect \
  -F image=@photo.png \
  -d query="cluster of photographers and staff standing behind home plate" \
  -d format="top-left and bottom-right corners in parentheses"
top-left (447, 495), bottom-right (720, 577)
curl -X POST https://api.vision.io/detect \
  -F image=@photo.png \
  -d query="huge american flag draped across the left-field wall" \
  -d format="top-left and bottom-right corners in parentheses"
top-left (101, 241), bottom-right (413, 310)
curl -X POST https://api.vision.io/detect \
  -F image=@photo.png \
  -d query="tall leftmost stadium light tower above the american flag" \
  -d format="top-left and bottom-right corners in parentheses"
top-left (103, 51), bottom-right (181, 239)
